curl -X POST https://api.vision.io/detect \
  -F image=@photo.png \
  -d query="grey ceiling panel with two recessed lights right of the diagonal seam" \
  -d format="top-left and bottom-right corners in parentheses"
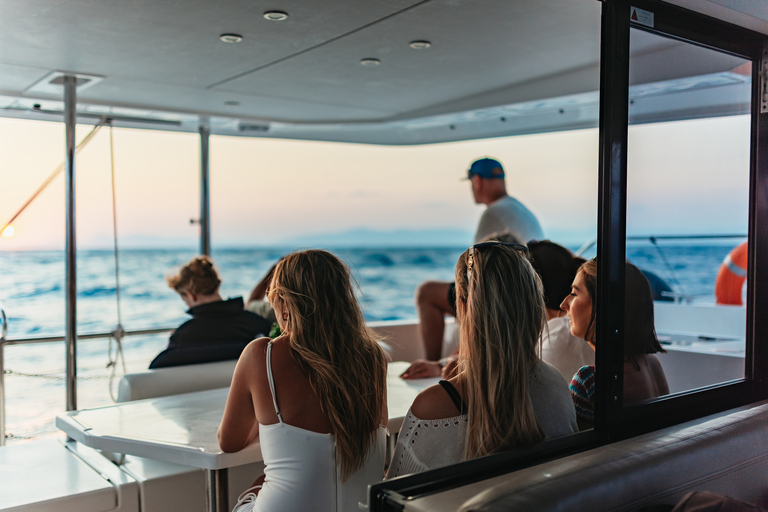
top-left (217, 0), bottom-right (600, 121)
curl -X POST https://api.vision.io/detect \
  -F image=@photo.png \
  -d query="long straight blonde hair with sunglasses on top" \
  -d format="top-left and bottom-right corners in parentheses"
top-left (456, 244), bottom-right (546, 459)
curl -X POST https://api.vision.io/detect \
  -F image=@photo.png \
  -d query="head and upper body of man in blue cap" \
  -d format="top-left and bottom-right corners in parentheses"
top-left (467, 158), bottom-right (544, 244)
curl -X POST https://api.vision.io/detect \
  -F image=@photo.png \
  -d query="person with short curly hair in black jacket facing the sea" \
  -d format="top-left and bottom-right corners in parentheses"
top-left (149, 256), bottom-right (270, 368)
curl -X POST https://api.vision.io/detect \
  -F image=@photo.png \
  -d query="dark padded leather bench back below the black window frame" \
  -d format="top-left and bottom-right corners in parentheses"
top-left (392, 402), bottom-right (768, 512)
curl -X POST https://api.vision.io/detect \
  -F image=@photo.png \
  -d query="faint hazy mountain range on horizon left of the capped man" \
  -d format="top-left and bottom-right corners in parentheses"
top-left (274, 228), bottom-right (472, 247)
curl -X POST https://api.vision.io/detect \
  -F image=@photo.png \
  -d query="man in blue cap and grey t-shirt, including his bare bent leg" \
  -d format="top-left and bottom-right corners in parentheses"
top-left (402, 158), bottom-right (544, 379)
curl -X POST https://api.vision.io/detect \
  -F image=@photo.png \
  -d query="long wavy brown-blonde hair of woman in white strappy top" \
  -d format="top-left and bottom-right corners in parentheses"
top-left (268, 250), bottom-right (387, 481)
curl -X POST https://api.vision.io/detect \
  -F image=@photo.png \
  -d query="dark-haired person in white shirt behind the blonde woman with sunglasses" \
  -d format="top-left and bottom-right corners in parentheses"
top-left (528, 240), bottom-right (595, 382)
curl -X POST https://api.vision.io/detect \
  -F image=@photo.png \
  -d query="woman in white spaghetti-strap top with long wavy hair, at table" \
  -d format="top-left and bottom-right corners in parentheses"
top-left (219, 250), bottom-right (387, 512)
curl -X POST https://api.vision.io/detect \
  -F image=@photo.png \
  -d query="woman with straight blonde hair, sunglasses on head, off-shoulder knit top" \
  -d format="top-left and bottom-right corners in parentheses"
top-left (387, 242), bottom-right (577, 478)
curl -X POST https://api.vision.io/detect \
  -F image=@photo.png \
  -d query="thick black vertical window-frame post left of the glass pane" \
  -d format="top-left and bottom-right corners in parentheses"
top-left (595, 0), bottom-right (630, 434)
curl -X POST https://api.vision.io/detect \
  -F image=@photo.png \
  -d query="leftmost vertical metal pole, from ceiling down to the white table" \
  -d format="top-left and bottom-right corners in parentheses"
top-left (64, 76), bottom-right (77, 411)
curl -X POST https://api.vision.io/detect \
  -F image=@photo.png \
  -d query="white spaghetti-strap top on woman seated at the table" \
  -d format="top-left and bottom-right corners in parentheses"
top-left (254, 343), bottom-right (387, 512)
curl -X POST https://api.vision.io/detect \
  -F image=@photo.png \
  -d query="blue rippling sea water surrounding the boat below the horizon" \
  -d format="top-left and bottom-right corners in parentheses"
top-left (0, 243), bottom-right (734, 442)
